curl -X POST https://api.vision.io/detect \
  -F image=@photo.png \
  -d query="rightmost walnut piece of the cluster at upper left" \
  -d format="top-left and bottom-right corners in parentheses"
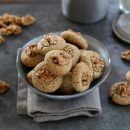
top-left (21, 15), bottom-right (36, 26)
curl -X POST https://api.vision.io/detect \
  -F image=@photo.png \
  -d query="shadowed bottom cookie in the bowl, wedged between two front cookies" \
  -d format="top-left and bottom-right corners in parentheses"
top-left (57, 72), bottom-right (76, 95)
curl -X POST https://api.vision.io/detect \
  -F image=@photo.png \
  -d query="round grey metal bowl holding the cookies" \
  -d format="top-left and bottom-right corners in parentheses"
top-left (16, 32), bottom-right (111, 100)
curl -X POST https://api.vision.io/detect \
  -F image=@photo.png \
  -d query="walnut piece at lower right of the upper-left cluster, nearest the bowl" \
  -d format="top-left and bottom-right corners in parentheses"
top-left (7, 25), bottom-right (22, 35)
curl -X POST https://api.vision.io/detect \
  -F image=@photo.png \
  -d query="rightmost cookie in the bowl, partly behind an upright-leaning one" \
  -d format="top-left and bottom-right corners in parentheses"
top-left (80, 50), bottom-right (105, 79)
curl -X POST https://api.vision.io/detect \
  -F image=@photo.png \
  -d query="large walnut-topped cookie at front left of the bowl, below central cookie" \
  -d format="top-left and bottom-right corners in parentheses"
top-left (32, 62), bottom-right (63, 93)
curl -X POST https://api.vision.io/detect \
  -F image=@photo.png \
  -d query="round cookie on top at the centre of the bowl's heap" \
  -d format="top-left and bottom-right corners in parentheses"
top-left (44, 50), bottom-right (72, 75)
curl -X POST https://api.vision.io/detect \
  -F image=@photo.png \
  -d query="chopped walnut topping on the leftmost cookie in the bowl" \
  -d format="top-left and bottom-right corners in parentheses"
top-left (25, 44), bottom-right (37, 57)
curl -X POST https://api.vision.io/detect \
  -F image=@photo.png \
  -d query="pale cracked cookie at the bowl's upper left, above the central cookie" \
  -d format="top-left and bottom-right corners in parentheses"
top-left (37, 33), bottom-right (66, 55)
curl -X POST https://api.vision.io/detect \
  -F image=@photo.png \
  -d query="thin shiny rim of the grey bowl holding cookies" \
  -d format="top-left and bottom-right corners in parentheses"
top-left (16, 32), bottom-right (111, 100)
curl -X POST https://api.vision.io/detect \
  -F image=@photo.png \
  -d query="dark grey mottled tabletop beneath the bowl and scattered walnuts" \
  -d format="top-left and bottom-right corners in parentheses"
top-left (0, 0), bottom-right (130, 130)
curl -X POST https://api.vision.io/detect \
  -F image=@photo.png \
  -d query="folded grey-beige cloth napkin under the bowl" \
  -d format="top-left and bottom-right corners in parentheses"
top-left (17, 74), bottom-right (102, 122)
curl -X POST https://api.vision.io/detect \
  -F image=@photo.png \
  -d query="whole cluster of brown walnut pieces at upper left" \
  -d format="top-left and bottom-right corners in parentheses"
top-left (0, 13), bottom-right (35, 44)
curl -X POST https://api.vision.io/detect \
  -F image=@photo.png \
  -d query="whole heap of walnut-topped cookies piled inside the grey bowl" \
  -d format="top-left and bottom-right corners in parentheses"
top-left (21, 29), bottom-right (105, 95)
